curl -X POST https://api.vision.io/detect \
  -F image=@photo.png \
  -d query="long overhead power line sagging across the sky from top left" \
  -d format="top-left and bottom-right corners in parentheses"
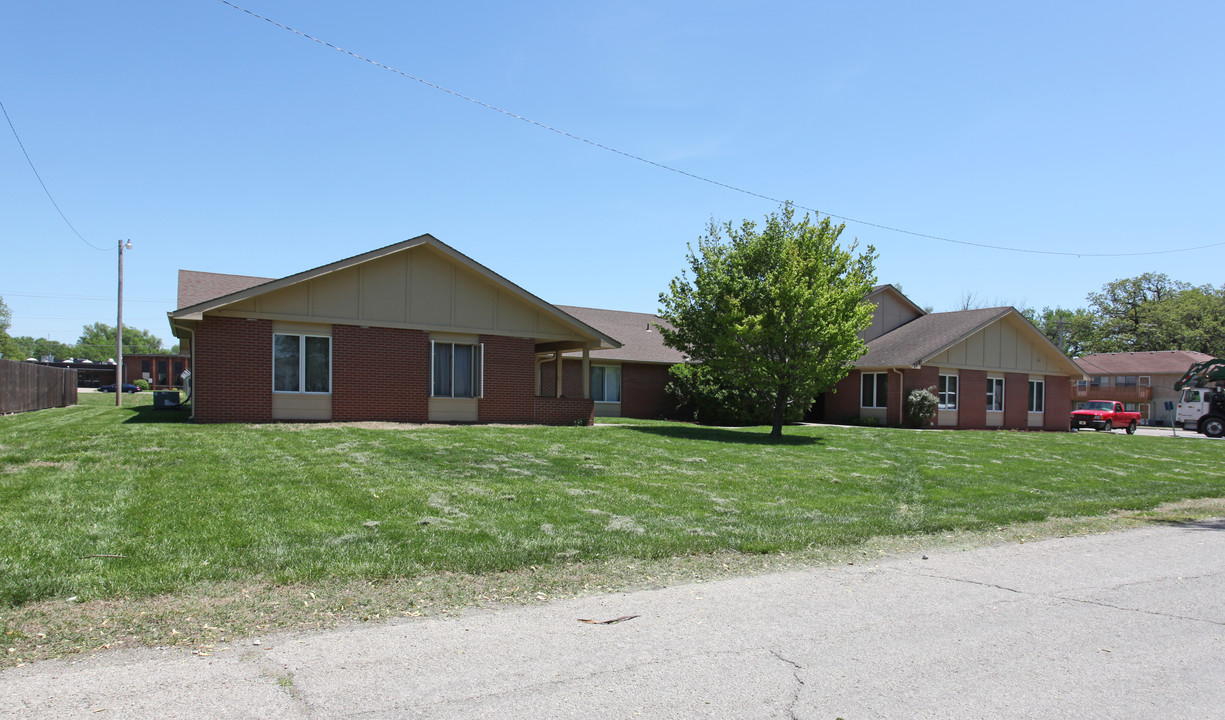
top-left (218, 0), bottom-right (1225, 257)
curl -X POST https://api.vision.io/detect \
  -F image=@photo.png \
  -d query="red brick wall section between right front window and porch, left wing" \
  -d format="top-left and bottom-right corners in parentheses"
top-left (477, 336), bottom-right (536, 422)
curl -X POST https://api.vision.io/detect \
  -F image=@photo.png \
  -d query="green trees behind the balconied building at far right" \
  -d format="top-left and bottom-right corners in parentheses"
top-left (1023, 273), bottom-right (1225, 358)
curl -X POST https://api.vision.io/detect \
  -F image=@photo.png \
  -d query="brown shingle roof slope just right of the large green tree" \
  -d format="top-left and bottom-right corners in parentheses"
top-left (855, 307), bottom-right (1016, 367)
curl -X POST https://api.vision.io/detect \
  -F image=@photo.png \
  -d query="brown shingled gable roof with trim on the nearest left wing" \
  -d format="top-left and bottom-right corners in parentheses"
top-left (168, 234), bottom-right (621, 349)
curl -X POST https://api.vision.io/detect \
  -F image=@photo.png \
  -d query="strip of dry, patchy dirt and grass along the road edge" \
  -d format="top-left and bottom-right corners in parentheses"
top-left (0, 498), bottom-right (1225, 667)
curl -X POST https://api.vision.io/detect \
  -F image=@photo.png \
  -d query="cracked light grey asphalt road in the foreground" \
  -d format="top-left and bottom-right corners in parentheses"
top-left (0, 520), bottom-right (1225, 720)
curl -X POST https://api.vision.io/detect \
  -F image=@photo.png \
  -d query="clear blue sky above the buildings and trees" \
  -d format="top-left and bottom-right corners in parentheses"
top-left (0, 0), bottom-right (1225, 344)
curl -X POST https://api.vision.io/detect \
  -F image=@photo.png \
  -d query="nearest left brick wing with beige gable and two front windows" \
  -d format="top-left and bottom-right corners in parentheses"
top-left (169, 235), bottom-right (620, 424)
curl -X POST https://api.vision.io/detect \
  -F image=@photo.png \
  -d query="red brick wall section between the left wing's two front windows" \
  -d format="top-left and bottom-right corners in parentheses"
top-left (332, 324), bottom-right (430, 422)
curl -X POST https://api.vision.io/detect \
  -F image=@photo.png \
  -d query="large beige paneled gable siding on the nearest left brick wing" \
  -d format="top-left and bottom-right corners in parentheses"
top-left (208, 246), bottom-right (590, 340)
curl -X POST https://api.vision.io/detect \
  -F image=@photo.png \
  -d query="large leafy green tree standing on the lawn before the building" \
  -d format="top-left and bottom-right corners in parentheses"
top-left (659, 203), bottom-right (876, 437)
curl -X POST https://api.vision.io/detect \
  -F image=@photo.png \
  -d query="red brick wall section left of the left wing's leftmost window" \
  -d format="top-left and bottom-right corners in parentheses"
top-left (191, 315), bottom-right (272, 422)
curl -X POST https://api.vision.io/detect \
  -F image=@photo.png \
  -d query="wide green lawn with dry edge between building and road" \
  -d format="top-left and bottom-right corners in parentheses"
top-left (0, 393), bottom-right (1225, 664)
